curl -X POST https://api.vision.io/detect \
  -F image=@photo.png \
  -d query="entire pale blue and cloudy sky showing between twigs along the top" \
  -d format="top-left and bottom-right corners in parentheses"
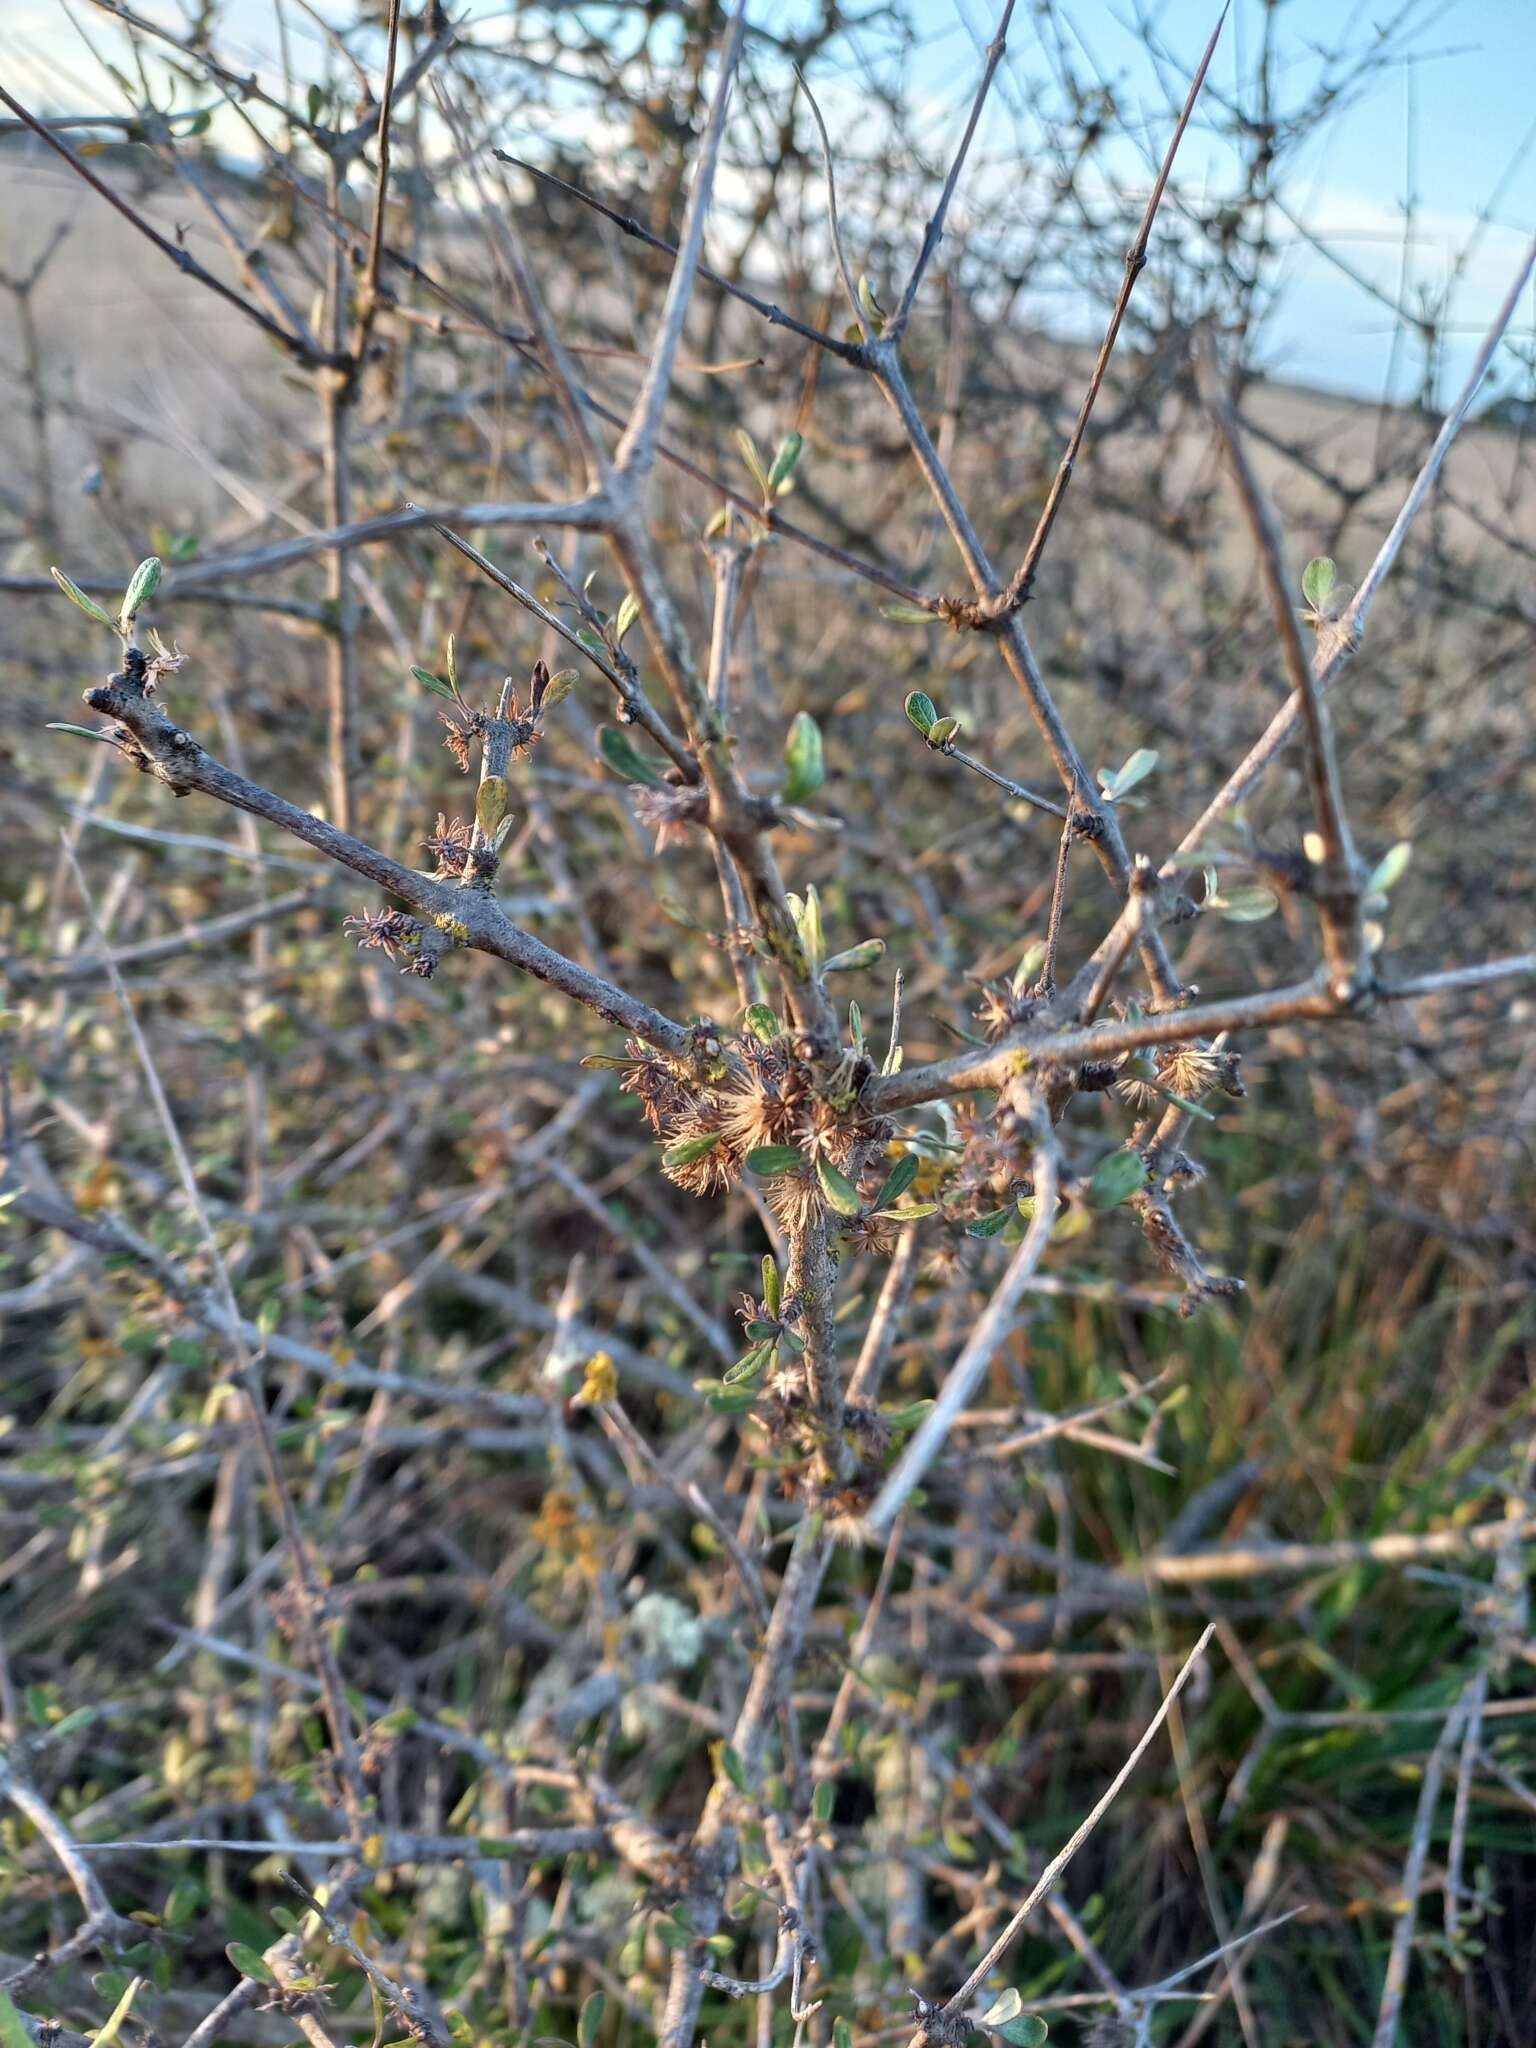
top-left (4, 0), bottom-right (1536, 401)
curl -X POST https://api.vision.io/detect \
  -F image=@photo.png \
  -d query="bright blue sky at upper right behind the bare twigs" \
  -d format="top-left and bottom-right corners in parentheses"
top-left (888, 0), bottom-right (1536, 401)
